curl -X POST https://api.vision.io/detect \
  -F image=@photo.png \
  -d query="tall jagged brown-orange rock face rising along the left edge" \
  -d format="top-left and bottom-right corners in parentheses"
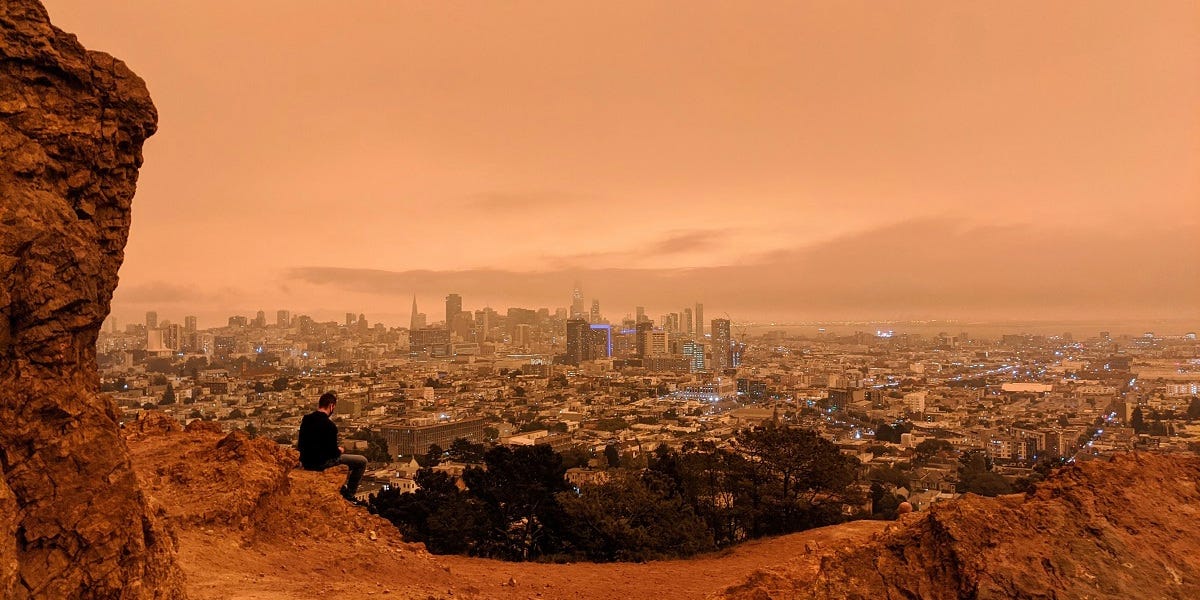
top-left (0, 0), bottom-right (182, 599)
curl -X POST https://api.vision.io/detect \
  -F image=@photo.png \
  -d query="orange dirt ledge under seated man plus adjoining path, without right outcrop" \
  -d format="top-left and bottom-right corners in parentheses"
top-left (128, 413), bottom-right (883, 600)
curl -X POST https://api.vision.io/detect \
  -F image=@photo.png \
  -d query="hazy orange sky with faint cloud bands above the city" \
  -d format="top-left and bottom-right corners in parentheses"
top-left (39, 0), bottom-right (1200, 325)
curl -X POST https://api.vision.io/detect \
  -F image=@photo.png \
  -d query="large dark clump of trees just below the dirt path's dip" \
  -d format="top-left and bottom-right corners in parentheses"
top-left (372, 427), bottom-right (859, 560)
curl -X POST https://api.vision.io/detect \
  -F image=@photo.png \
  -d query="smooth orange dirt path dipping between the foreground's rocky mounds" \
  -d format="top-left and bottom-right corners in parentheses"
top-left (180, 521), bottom-right (884, 600)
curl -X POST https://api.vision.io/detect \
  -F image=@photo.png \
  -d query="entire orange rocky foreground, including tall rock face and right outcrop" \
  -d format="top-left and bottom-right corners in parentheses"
top-left (7, 0), bottom-right (1200, 600)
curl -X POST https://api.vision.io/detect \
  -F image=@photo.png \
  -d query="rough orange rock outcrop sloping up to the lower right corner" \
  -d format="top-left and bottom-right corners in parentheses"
top-left (725, 454), bottom-right (1200, 600)
